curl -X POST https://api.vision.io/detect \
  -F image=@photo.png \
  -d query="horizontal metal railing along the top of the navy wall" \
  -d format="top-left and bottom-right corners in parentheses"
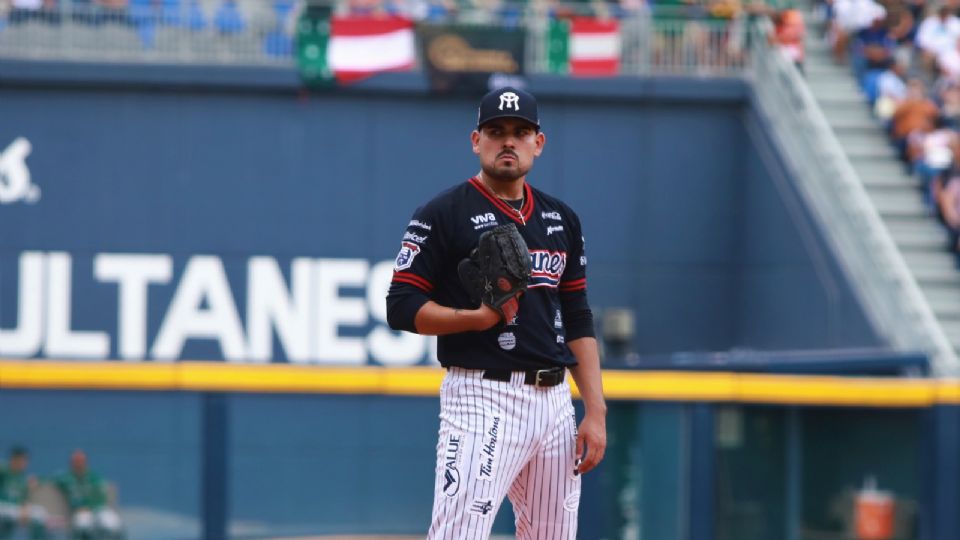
top-left (0, 0), bottom-right (747, 75)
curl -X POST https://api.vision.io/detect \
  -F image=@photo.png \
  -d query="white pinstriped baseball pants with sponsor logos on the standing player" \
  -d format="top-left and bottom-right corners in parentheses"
top-left (428, 368), bottom-right (580, 540)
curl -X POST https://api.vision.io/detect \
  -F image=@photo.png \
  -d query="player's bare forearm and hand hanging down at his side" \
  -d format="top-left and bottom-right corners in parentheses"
top-left (568, 337), bottom-right (607, 474)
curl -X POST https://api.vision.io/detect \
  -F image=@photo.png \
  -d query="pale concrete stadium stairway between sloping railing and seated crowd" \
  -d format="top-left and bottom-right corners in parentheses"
top-left (804, 25), bottom-right (960, 352)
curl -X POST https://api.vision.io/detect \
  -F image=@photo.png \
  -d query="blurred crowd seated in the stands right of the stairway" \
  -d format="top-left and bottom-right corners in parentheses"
top-left (819, 0), bottom-right (960, 252)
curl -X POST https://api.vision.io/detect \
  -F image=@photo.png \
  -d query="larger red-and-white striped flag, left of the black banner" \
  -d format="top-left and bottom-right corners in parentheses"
top-left (327, 16), bottom-right (416, 83)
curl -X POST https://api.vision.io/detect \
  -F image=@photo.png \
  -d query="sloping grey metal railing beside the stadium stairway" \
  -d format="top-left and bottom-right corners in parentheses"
top-left (750, 24), bottom-right (960, 376)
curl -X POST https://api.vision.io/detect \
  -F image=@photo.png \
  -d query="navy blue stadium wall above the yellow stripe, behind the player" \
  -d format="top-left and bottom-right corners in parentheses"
top-left (0, 65), bottom-right (881, 365)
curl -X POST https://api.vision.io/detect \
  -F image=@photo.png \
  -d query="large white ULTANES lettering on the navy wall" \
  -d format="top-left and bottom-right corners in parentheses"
top-left (0, 251), bottom-right (436, 365)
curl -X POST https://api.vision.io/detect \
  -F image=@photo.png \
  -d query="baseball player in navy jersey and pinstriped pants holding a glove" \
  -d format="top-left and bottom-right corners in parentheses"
top-left (387, 87), bottom-right (606, 540)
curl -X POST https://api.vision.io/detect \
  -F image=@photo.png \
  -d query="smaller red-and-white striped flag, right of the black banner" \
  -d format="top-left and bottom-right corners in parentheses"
top-left (569, 17), bottom-right (621, 76)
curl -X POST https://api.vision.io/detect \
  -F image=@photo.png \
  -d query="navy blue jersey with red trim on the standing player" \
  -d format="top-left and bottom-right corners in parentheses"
top-left (387, 178), bottom-right (593, 370)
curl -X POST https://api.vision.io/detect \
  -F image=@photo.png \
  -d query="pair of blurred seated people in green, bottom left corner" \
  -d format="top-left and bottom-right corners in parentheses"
top-left (0, 446), bottom-right (124, 540)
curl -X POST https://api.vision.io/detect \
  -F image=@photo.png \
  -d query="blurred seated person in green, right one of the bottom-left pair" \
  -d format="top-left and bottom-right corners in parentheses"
top-left (54, 450), bottom-right (122, 540)
